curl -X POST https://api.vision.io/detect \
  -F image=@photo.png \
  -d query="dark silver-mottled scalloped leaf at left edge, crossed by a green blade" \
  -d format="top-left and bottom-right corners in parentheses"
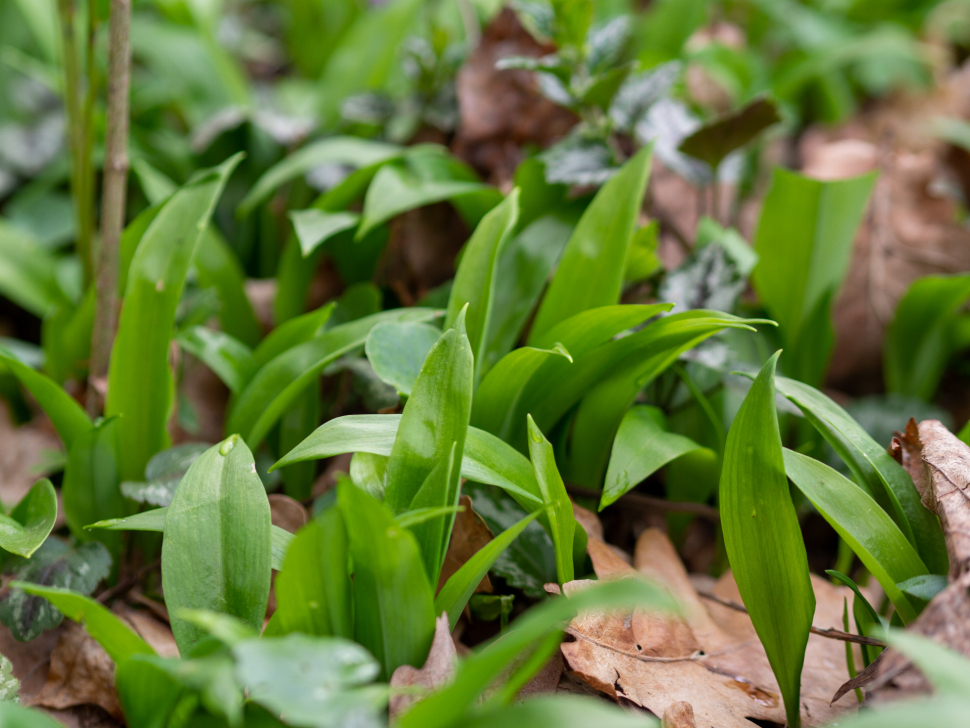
top-left (0, 538), bottom-right (111, 642)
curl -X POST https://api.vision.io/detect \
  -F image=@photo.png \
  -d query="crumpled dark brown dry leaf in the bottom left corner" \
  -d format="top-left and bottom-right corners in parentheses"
top-left (24, 622), bottom-right (122, 720)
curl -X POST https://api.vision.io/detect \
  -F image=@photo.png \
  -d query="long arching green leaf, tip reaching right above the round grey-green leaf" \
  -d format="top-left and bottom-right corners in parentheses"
top-left (227, 308), bottom-right (436, 447)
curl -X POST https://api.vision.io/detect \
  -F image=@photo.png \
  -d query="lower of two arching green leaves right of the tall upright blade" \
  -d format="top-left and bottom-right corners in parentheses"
top-left (784, 449), bottom-right (926, 623)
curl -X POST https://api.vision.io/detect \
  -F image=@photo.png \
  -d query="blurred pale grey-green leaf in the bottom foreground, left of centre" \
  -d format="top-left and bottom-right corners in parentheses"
top-left (232, 634), bottom-right (387, 728)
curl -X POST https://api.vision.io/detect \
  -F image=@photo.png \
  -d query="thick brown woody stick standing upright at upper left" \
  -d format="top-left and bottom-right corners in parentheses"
top-left (87, 0), bottom-right (131, 417)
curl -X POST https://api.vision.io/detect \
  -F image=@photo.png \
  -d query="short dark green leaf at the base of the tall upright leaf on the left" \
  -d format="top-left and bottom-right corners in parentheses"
top-left (61, 418), bottom-right (123, 559)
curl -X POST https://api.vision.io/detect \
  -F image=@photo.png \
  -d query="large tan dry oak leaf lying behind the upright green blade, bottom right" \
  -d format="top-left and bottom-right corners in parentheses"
top-left (562, 529), bottom-right (852, 728)
